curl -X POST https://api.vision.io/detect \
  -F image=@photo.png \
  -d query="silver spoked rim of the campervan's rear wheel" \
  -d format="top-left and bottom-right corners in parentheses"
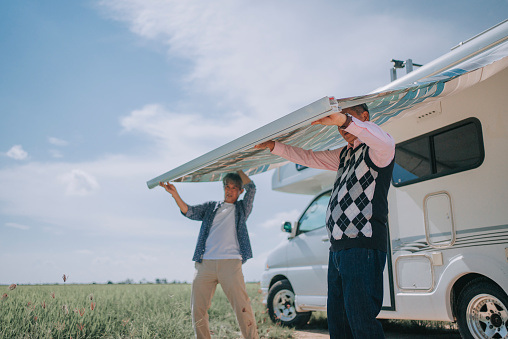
top-left (466, 294), bottom-right (508, 339)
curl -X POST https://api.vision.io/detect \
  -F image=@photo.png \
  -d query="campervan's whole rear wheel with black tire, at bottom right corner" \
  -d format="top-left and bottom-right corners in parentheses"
top-left (457, 279), bottom-right (508, 339)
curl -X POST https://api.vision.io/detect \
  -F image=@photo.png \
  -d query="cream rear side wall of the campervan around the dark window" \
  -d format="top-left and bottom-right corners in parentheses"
top-left (380, 59), bottom-right (508, 321)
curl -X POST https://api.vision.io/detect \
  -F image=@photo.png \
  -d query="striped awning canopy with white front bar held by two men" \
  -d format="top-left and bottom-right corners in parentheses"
top-left (147, 22), bottom-right (508, 188)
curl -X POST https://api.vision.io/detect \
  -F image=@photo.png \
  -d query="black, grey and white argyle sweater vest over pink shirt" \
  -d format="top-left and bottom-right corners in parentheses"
top-left (326, 144), bottom-right (394, 252)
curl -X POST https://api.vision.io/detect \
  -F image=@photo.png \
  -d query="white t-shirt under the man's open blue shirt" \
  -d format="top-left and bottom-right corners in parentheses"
top-left (203, 202), bottom-right (242, 260)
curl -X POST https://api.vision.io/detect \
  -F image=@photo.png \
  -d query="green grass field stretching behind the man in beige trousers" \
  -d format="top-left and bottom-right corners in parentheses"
top-left (0, 283), bottom-right (294, 339)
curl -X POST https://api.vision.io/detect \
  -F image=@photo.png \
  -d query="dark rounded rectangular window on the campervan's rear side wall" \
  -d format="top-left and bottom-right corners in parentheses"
top-left (392, 118), bottom-right (484, 186)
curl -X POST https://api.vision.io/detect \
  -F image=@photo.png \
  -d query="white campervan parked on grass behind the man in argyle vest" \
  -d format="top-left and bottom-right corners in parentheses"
top-left (261, 21), bottom-right (508, 338)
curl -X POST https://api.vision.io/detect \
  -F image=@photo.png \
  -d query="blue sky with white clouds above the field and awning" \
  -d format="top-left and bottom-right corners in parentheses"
top-left (0, 0), bottom-right (508, 284)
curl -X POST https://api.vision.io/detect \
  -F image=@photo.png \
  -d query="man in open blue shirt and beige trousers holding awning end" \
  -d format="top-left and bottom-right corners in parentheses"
top-left (159, 171), bottom-right (258, 339)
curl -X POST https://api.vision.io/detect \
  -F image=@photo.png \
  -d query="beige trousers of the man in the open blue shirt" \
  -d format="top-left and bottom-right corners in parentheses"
top-left (191, 259), bottom-right (258, 339)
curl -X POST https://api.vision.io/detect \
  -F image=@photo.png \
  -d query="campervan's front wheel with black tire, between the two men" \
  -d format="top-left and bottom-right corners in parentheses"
top-left (267, 279), bottom-right (312, 327)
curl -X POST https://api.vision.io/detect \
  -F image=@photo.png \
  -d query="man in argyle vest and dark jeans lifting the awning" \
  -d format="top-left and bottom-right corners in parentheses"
top-left (256, 104), bottom-right (395, 339)
